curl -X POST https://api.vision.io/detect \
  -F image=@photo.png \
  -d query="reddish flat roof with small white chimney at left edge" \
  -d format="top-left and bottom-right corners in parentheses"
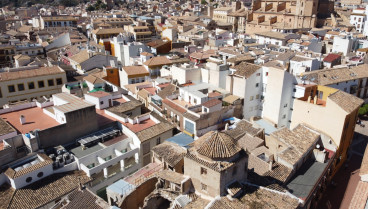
top-left (0, 107), bottom-right (60, 134)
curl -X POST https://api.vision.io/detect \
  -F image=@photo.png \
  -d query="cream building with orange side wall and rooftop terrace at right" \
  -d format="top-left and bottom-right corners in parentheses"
top-left (290, 84), bottom-right (363, 174)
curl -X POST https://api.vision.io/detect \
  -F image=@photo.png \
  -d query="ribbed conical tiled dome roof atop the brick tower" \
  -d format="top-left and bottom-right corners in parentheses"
top-left (197, 131), bottom-right (241, 159)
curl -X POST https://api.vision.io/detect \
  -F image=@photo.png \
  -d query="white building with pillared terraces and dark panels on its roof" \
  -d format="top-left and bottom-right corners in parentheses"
top-left (66, 126), bottom-right (139, 193)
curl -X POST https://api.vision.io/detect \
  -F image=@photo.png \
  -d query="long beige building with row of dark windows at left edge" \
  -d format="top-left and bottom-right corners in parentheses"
top-left (0, 66), bottom-right (67, 106)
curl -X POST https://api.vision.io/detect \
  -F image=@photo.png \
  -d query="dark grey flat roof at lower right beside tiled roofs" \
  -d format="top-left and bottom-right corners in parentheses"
top-left (287, 160), bottom-right (328, 200)
